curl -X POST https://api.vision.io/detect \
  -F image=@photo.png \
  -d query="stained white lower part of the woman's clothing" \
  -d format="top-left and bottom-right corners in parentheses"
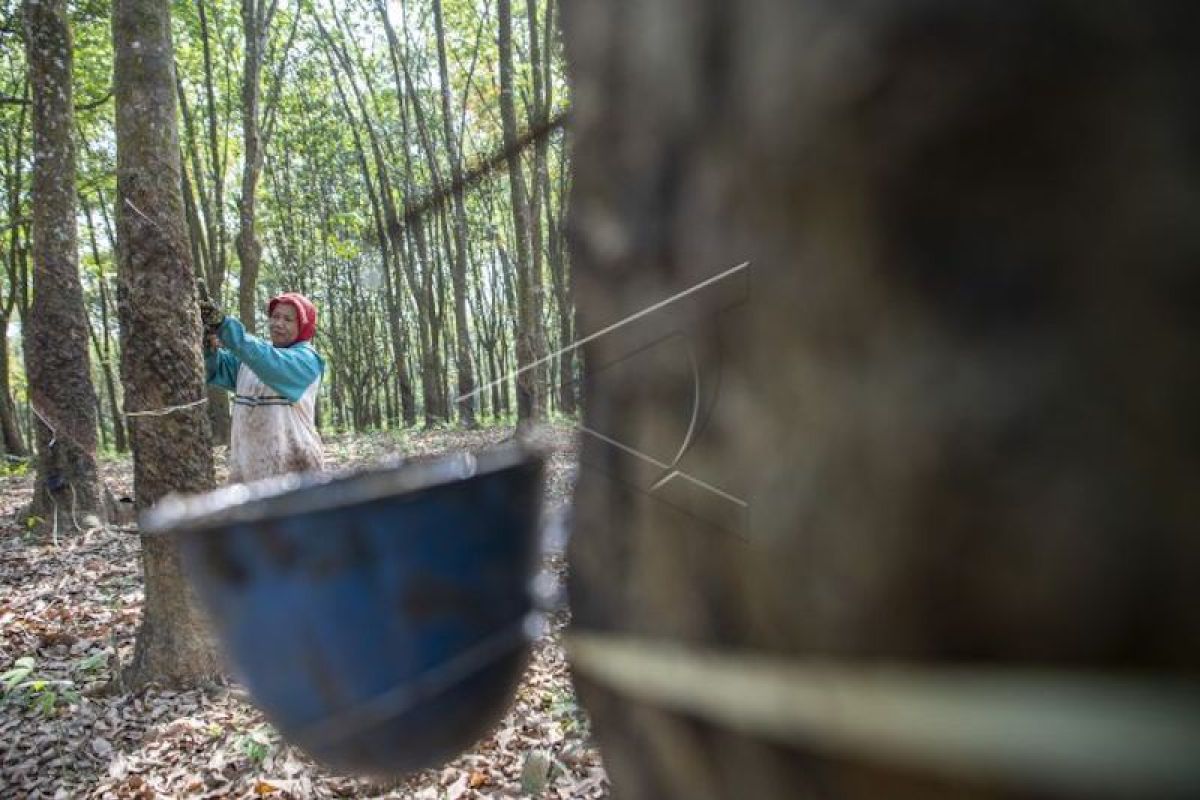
top-left (229, 365), bottom-right (324, 483)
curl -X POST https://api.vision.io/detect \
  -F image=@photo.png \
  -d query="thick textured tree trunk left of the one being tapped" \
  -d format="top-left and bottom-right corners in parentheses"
top-left (25, 0), bottom-right (104, 529)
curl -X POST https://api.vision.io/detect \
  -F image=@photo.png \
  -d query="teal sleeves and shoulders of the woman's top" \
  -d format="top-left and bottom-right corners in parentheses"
top-left (204, 317), bottom-right (325, 403)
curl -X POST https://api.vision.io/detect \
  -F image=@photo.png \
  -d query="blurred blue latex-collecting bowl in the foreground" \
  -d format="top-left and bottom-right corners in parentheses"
top-left (143, 447), bottom-right (542, 775)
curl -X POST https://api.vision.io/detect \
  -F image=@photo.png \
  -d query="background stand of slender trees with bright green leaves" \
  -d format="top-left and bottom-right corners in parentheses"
top-left (0, 0), bottom-right (576, 455)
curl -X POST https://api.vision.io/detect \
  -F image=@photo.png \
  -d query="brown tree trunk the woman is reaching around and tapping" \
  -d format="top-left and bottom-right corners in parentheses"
top-left (113, 0), bottom-right (220, 687)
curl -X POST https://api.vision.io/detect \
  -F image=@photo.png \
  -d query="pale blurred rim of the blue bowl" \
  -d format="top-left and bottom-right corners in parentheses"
top-left (139, 443), bottom-right (545, 534)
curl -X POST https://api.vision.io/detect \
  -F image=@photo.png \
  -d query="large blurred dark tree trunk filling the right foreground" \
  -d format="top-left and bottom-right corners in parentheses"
top-left (563, 0), bottom-right (1200, 800)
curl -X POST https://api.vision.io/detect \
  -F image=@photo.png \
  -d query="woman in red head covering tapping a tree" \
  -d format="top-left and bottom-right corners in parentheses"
top-left (200, 291), bottom-right (325, 483)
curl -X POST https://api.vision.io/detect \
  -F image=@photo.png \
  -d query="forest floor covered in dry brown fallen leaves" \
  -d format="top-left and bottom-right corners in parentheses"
top-left (0, 427), bottom-right (608, 800)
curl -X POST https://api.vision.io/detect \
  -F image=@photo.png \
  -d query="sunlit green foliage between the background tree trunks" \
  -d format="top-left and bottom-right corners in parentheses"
top-left (0, 0), bottom-right (570, 438)
